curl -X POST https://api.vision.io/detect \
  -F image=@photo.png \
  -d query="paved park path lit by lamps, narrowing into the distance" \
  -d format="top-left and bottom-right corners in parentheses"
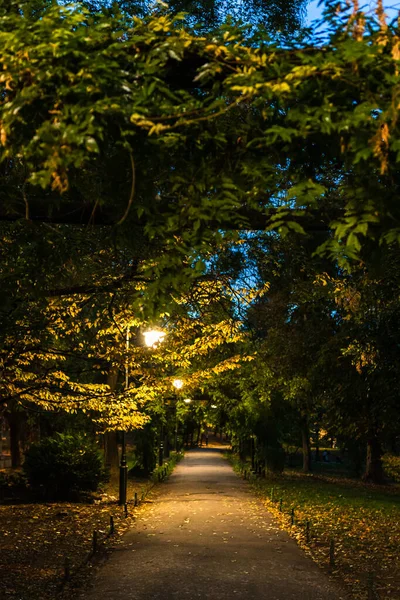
top-left (83, 448), bottom-right (345, 600)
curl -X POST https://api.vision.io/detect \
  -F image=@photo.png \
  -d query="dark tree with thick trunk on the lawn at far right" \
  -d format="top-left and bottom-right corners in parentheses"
top-left (314, 247), bottom-right (399, 483)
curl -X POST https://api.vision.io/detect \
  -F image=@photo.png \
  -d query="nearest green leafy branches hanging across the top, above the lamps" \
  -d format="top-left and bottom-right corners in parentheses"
top-left (0, 0), bottom-right (399, 256)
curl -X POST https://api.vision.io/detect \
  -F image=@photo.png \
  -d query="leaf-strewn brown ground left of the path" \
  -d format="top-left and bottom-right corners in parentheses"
top-left (0, 482), bottom-right (150, 600)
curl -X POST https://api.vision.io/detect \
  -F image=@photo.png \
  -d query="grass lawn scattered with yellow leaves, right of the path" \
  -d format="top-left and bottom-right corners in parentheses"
top-left (231, 464), bottom-right (400, 600)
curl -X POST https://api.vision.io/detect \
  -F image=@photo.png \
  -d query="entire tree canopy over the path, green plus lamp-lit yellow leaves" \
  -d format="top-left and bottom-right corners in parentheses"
top-left (0, 0), bottom-right (400, 480)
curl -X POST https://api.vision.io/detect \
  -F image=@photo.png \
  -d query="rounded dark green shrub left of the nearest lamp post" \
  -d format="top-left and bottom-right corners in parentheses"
top-left (23, 433), bottom-right (105, 500)
